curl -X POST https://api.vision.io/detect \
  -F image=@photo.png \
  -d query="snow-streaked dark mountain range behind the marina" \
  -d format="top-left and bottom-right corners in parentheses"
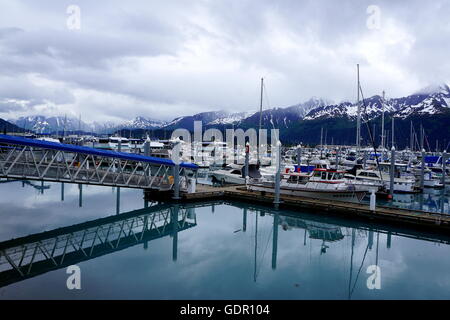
top-left (3, 84), bottom-right (450, 148)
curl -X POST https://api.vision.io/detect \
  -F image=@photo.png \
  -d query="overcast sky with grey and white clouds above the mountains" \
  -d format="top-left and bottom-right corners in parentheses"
top-left (0, 0), bottom-right (450, 121)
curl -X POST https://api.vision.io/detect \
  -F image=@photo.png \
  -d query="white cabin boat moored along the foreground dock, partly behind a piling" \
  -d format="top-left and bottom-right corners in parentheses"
top-left (248, 169), bottom-right (367, 202)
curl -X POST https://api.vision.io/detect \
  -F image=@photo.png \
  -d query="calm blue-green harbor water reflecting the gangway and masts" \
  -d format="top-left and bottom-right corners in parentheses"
top-left (0, 182), bottom-right (450, 299)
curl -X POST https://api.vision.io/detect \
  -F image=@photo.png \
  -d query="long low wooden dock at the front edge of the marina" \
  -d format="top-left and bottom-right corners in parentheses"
top-left (175, 185), bottom-right (450, 234)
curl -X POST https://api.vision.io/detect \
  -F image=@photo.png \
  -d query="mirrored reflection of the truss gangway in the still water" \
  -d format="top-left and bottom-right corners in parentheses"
top-left (0, 204), bottom-right (197, 287)
